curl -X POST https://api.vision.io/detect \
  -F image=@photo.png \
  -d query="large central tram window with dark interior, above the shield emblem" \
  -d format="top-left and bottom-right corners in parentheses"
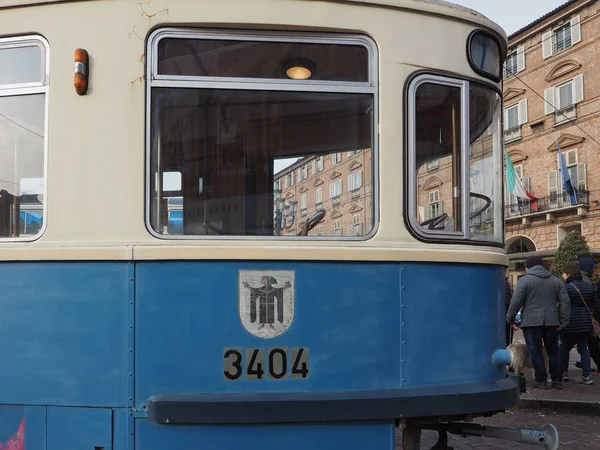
top-left (146, 28), bottom-right (378, 239)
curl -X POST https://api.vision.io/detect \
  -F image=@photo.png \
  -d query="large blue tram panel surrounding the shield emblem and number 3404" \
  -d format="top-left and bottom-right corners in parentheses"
top-left (135, 262), bottom-right (400, 405)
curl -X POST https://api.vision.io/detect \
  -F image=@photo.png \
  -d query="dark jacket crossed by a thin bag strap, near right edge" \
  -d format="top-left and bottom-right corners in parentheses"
top-left (563, 278), bottom-right (600, 333)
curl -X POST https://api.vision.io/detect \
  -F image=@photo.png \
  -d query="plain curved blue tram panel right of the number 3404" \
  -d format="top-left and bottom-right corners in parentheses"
top-left (402, 264), bottom-right (506, 386)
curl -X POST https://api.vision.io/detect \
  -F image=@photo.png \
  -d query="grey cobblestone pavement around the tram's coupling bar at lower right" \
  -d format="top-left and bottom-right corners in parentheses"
top-left (396, 411), bottom-right (600, 450)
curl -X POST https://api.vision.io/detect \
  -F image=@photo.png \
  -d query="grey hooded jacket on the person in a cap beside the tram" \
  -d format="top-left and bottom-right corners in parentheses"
top-left (506, 266), bottom-right (571, 328)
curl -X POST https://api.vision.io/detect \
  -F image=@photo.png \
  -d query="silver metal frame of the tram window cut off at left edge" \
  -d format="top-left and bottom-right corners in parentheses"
top-left (0, 34), bottom-right (50, 243)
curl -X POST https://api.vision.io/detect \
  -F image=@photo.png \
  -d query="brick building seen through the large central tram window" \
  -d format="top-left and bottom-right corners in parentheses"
top-left (275, 149), bottom-right (373, 236)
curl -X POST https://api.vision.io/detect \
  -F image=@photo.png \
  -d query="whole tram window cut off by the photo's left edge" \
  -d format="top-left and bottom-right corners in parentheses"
top-left (0, 37), bottom-right (48, 239)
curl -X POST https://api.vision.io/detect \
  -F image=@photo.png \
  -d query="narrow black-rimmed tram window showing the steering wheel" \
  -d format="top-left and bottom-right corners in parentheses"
top-left (408, 76), bottom-right (504, 243)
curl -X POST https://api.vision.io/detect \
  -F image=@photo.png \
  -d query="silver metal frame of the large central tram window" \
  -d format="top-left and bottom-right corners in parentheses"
top-left (144, 26), bottom-right (380, 241)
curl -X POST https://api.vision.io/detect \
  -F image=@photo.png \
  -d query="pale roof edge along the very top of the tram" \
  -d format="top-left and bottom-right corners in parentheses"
top-left (0, 0), bottom-right (506, 38)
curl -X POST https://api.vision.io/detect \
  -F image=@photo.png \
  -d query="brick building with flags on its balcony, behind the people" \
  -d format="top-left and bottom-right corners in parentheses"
top-left (504, 0), bottom-right (600, 281)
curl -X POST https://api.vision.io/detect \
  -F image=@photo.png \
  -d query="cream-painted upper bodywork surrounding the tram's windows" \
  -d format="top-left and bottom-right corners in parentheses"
top-left (0, 0), bottom-right (506, 253)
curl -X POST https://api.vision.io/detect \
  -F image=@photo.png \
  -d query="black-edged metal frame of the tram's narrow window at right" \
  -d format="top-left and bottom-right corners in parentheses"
top-left (403, 70), bottom-right (506, 248)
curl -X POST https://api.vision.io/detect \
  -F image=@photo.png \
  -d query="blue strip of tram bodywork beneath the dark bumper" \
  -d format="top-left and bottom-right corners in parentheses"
top-left (136, 421), bottom-right (395, 450)
